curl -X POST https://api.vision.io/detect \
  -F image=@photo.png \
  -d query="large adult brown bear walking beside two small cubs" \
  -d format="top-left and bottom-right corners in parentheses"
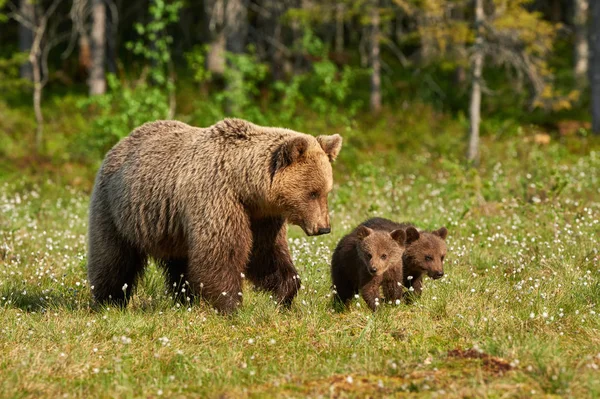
top-left (88, 119), bottom-right (342, 313)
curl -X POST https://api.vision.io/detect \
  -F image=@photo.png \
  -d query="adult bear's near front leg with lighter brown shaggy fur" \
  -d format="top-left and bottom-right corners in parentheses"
top-left (187, 206), bottom-right (252, 314)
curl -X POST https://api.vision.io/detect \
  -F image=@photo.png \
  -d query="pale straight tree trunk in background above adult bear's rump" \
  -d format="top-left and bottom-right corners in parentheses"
top-left (89, 0), bottom-right (106, 96)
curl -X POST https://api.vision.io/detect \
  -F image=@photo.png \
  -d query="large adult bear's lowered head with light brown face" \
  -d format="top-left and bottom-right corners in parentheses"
top-left (269, 134), bottom-right (342, 236)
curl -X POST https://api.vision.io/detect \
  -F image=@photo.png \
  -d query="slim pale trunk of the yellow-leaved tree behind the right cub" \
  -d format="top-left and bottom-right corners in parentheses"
top-left (467, 0), bottom-right (484, 165)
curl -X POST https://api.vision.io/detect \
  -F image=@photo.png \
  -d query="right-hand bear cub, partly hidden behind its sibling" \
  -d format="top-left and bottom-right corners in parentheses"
top-left (363, 218), bottom-right (448, 300)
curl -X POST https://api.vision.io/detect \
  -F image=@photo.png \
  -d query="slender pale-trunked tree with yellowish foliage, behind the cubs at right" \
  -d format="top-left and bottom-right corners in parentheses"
top-left (418, 0), bottom-right (560, 164)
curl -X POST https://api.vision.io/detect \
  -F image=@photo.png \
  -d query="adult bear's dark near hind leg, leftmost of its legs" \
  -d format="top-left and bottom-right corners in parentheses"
top-left (87, 217), bottom-right (146, 306)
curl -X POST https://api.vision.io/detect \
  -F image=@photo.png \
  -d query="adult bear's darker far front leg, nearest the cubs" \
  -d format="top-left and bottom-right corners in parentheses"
top-left (247, 218), bottom-right (301, 307)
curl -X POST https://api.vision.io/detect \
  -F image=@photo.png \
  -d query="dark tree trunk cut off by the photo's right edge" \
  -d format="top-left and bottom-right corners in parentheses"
top-left (590, 0), bottom-right (600, 134)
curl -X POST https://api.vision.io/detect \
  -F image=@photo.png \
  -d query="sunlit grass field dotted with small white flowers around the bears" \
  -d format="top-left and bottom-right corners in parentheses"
top-left (0, 139), bottom-right (600, 398)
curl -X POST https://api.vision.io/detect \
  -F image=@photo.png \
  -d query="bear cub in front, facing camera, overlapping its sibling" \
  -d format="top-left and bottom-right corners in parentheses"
top-left (331, 225), bottom-right (406, 311)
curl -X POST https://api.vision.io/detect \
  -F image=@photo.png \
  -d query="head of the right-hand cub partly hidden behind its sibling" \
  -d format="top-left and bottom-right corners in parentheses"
top-left (404, 227), bottom-right (448, 279)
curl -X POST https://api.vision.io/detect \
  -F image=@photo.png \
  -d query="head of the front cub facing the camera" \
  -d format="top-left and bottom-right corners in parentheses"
top-left (356, 225), bottom-right (406, 276)
